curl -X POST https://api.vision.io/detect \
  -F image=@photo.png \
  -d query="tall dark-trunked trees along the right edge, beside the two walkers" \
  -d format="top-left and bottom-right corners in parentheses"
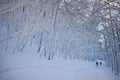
top-left (91, 0), bottom-right (120, 75)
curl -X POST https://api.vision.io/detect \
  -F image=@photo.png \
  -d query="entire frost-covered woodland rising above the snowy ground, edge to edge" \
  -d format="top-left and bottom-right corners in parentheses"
top-left (0, 0), bottom-right (120, 75)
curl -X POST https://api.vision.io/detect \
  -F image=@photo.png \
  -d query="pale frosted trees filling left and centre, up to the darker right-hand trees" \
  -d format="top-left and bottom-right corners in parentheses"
top-left (0, 0), bottom-right (100, 60)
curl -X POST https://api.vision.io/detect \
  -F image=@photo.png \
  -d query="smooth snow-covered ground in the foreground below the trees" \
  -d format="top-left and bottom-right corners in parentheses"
top-left (0, 53), bottom-right (115, 80)
